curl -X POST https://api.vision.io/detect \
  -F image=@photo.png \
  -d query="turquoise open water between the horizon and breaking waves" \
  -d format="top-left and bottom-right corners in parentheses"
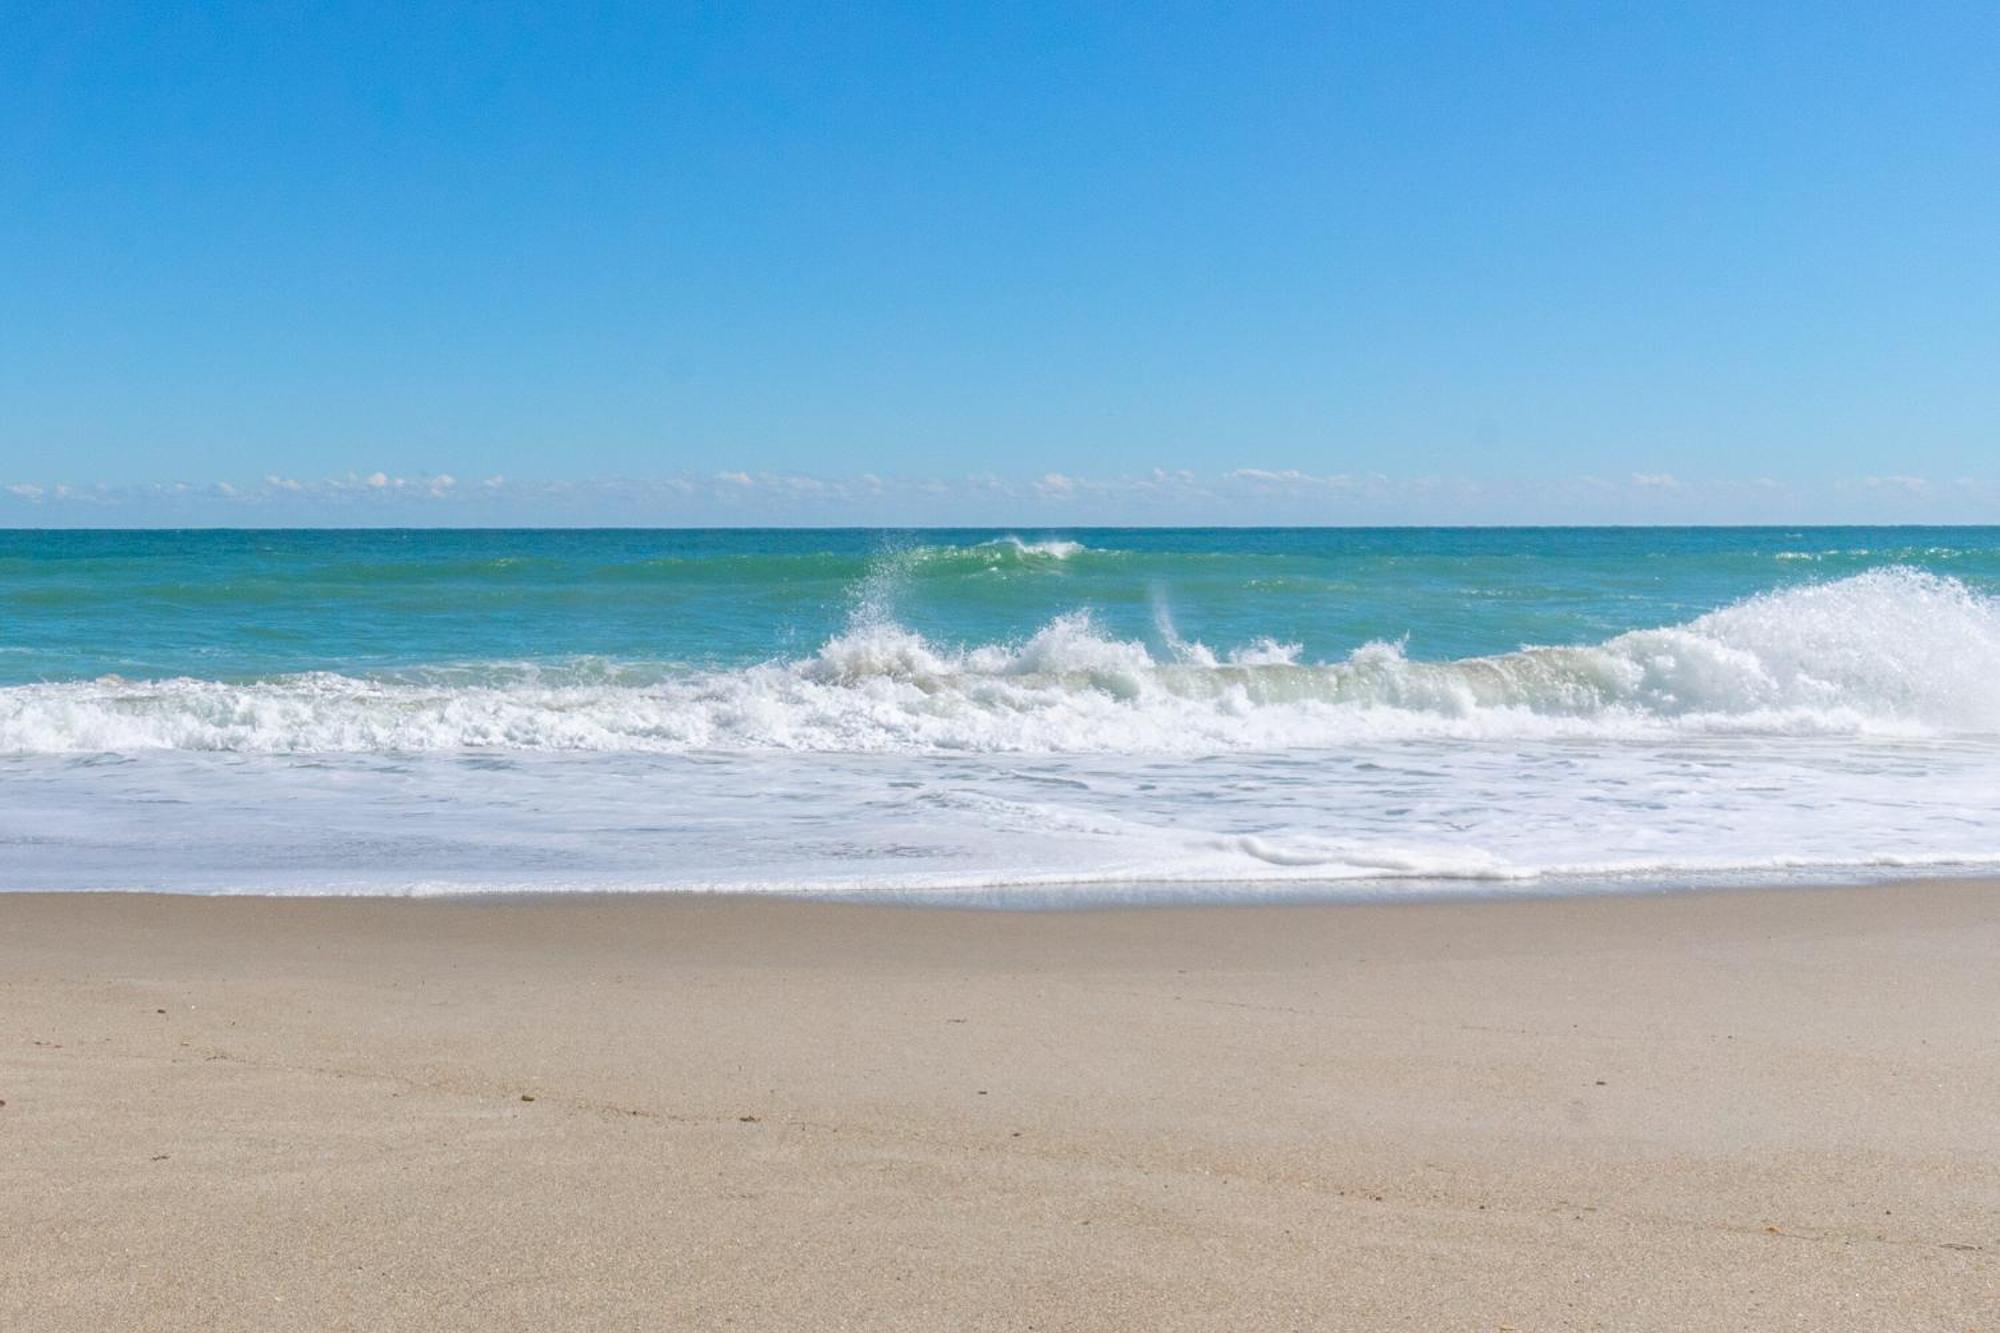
top-left (0, 528), bottom-right (2000, 685)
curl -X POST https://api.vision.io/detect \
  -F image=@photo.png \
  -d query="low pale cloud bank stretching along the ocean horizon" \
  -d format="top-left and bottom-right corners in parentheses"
top-left (0, 466), bottom-right (2000, 526)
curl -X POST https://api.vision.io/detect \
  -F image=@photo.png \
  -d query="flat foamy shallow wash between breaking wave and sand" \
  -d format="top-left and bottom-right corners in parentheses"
top-left (0, 737), bottom-right (2000, 901)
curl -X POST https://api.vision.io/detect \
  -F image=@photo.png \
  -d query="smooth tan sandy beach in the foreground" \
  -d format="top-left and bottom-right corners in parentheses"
top-left (0, 881), bottom-right (2000, 1329)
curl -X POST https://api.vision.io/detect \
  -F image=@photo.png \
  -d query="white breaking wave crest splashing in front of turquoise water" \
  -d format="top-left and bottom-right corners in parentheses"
top-left (0, 568), bottom-right (2000, 755)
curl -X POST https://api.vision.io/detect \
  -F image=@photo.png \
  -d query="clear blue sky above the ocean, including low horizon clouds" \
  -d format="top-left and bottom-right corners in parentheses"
top-left (0, 0), bottom-right (2000, 524)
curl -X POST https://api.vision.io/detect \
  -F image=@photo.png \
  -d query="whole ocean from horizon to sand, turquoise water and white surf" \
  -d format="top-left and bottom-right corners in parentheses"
top-left (0, 528), bottom-right (2000, 905)
